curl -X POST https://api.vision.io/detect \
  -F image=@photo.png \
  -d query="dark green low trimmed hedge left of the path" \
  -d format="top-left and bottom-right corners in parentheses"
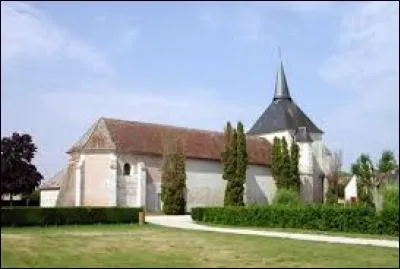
top-left (1, 207), bottom-right (143, 227)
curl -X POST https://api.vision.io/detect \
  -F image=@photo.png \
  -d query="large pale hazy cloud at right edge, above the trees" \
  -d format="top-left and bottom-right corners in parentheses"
top-left (321, 2), bottom-right (399, 168)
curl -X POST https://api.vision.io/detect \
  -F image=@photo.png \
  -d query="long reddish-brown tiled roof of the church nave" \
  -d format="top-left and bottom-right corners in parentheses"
top-left (68, 118), bottom-right (271, 165)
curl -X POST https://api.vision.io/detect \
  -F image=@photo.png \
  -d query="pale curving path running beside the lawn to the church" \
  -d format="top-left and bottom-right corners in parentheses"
top-left (146, 215), bottom-right (399, 248)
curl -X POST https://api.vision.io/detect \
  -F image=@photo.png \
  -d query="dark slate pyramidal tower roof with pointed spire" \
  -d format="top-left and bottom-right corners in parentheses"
top-left (248, 62), bottom-right (323, 135)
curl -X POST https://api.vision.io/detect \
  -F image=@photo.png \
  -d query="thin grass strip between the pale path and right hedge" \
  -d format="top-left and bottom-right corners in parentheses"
top-left (196, 221), bottom-right (399, 241)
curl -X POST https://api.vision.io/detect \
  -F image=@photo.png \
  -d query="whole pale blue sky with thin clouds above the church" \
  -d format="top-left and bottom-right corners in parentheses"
top-left (1, 1), bottom-right (399, 177)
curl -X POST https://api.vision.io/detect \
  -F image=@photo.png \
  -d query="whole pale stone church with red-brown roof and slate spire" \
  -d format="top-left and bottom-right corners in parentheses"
top-left (40, 59), bottom-right (332, 212)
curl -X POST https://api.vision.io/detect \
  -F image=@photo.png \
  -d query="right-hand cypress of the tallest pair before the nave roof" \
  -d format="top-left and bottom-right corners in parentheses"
top-left (235, 121), bottom-right (248, 205)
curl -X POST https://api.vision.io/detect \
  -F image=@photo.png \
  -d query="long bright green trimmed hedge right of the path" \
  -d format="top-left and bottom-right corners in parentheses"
top-left (191, 205), bottom-right (399, 235)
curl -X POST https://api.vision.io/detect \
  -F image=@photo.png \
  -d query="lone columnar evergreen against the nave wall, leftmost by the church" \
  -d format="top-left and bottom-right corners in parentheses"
top-left (161, 138), bottom-right (186, 215)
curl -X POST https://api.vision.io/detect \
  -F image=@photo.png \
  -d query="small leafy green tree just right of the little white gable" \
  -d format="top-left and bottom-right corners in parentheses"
top-left (351, 154), bottom-right (374, 206)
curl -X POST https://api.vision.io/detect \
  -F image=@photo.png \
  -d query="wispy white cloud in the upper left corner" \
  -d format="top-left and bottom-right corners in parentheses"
top-left (1, 2), bottom-right (113, 75)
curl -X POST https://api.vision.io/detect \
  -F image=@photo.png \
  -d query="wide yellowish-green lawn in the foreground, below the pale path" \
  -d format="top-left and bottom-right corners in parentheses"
top-left (1, 224), bottom-right (399, 268)
